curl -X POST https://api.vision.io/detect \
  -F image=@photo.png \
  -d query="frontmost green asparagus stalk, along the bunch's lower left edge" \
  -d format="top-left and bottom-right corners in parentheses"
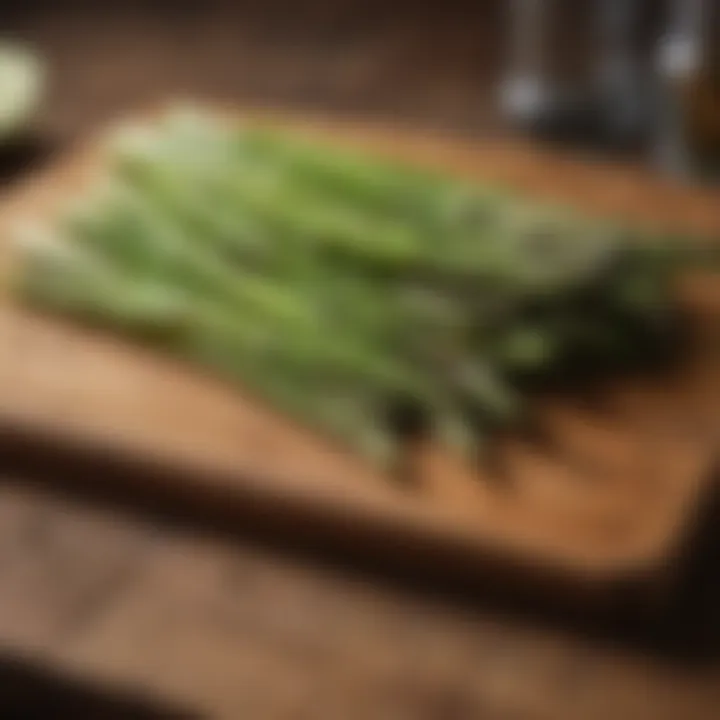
top-left (23, 242), bottom-right (396, 467)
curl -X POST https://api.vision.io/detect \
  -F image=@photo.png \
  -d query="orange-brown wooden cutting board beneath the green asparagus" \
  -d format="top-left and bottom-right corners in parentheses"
top-left (0, 104), bottom-right (720, 607)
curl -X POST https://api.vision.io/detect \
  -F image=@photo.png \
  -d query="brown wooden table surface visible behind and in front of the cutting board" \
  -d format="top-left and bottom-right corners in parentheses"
top-left (0, 0), bottom-right (720, 720)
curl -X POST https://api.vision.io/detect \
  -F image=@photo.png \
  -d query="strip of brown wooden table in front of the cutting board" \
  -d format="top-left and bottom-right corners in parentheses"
top-left (0, 477), bottom-right (720, 720)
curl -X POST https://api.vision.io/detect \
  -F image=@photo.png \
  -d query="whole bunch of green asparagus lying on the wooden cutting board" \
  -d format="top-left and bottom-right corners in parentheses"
top-left (19, 111), bottom-right (716, 466)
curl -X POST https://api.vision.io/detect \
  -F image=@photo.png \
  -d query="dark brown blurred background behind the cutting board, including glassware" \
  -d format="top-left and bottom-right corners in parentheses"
top-left (2, 0), bottom-right (718, 173)
